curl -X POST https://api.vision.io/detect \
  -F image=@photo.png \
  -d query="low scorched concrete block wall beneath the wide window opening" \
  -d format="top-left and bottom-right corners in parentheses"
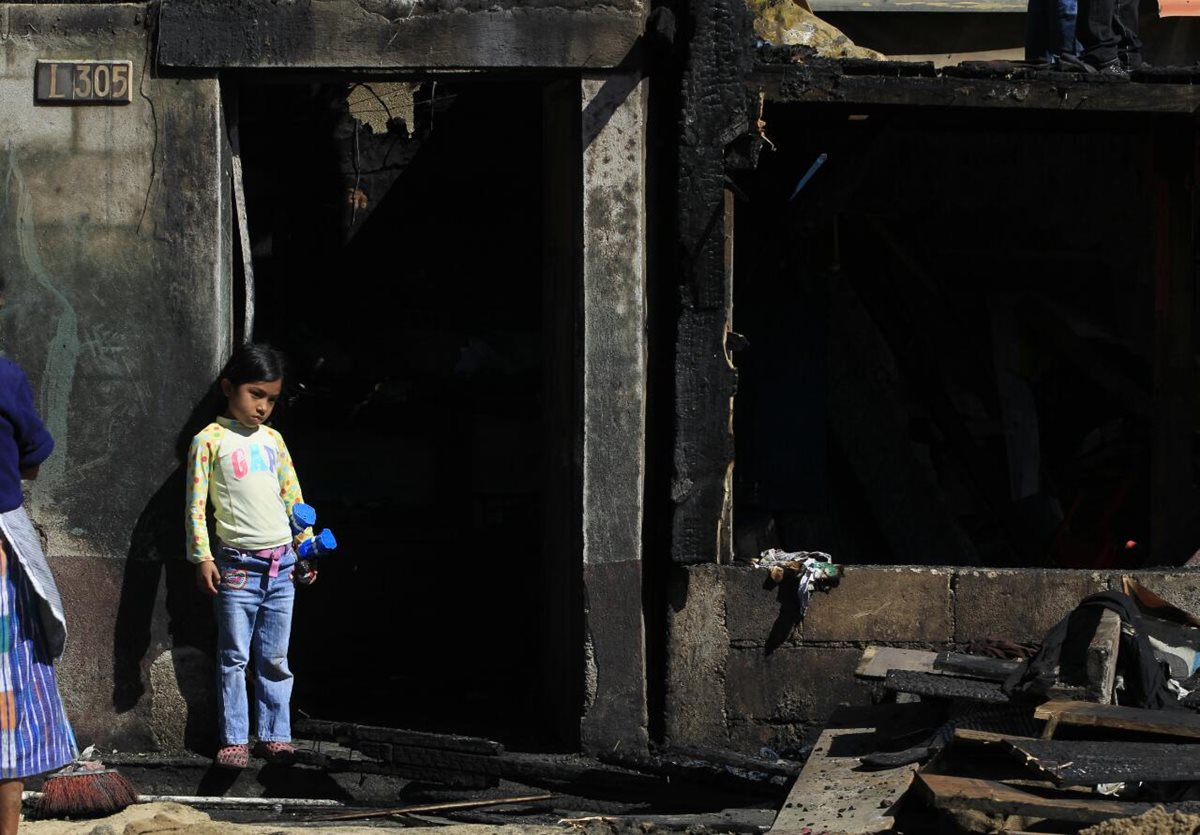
top-left (665, 565), bottom-right (1180, 752)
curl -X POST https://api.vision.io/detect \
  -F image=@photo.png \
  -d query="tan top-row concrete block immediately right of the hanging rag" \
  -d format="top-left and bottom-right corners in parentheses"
top-left (802, 567), bottom-right (953, 643)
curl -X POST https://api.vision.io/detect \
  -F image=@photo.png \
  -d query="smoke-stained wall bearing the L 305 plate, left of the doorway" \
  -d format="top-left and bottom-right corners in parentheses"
top-left (0, 5), bottom-right (230, 745)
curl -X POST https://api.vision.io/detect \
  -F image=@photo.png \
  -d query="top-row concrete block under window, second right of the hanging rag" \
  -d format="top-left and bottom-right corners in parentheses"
top-left (954, 569), bottom-right (1108, 643)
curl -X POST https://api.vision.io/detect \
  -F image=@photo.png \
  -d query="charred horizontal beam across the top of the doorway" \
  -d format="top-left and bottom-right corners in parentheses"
top-left (158, 0), bottom-right (646, 70)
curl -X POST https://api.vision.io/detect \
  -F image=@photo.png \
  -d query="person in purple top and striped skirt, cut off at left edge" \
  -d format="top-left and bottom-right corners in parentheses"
top-left (0, 276), bottom-right (77, 835)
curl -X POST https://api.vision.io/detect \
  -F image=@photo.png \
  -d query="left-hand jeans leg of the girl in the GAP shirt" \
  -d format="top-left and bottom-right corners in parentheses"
top-left (214, 564), bottom-right (263, 745)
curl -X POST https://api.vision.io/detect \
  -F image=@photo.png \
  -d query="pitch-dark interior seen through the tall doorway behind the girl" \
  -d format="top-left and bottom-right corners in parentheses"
top-left (238, 79), bottom-right (577, 749)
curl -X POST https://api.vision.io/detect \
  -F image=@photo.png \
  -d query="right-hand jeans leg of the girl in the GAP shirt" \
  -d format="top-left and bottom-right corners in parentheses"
top-left (252, 570), bottom-right (295, 743)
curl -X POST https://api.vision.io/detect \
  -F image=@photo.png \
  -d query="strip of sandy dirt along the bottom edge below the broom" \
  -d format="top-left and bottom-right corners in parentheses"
top-left (20, 803), bottom-right (566, 835)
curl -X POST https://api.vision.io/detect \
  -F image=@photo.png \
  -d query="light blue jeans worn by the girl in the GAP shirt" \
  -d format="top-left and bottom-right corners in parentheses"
top-left (216, 546), bottom-right (296, 745)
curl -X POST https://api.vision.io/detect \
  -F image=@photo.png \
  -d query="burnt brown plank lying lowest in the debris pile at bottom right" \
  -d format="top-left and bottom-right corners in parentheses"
top-left (913, 774), bottom-right (1200, 823)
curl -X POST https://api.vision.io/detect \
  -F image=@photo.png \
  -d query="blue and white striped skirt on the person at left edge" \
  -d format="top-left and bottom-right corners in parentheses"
top-left (0, 540), bottom-right (78, 780)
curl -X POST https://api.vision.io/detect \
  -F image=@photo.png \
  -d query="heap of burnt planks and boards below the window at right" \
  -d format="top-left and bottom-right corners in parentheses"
top-left (772, 599), bottom-right (1200, 835)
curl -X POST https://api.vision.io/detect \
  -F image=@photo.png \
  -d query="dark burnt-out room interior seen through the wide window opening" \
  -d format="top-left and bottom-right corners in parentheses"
top-left (733, 106), bottom-right (1200, 569)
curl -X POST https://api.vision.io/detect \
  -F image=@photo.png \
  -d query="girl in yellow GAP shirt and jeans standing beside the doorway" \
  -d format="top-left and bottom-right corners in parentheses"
top-left (187, 344), bottom-right (312, 768)
